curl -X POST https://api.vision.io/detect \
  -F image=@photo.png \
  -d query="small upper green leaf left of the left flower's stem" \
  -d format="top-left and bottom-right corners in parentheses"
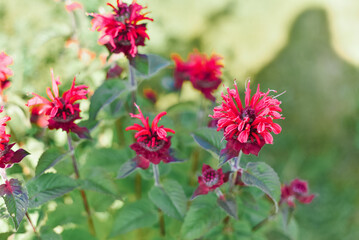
top-left (35, 148), bottom-right (68, 177)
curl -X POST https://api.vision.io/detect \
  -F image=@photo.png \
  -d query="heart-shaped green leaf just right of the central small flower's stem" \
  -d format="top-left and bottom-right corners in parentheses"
top-left (148, 180), bottom-right (187, 220)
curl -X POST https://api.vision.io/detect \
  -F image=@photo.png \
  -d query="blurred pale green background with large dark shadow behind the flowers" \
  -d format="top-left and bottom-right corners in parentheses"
top-left (0, 0), bottom-right (359, 240)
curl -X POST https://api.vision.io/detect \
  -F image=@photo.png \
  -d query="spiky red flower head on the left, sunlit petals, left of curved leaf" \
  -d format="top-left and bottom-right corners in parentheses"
top-left (26, 70), bottom-right (88, 138)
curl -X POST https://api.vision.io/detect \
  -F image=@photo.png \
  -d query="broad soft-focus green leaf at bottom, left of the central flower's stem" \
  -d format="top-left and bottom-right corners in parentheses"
top-left (110, 200), bottom-right (157, 237)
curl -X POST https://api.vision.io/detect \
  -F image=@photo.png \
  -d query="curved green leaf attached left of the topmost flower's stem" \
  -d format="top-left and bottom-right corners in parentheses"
top-left (89, 79), bottom-right (130, 120)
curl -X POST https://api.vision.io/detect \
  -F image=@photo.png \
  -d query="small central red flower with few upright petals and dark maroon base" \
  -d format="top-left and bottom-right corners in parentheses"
top-left (126, 104), bottom-right (175, 169)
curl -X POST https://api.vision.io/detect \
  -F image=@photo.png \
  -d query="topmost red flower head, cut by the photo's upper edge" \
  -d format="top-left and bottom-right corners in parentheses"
top-left (90, 0), bottom-right (153, 57)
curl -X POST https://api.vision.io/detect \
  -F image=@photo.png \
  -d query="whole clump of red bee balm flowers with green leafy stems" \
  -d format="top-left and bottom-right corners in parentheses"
top-left (0, 0), bottom-right (315, 239)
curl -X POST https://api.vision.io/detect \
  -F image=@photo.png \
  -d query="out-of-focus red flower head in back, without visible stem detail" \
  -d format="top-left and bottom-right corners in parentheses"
top-left (172, 51), bottom-right (223, 101)
